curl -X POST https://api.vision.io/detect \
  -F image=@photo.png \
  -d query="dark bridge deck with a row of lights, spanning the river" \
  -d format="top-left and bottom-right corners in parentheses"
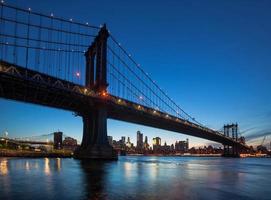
top-left (0, 61), bottom-right (249, 149)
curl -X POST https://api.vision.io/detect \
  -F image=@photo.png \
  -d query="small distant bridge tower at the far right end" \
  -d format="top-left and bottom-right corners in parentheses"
top-left (223, 123), bottom-right (240, 157)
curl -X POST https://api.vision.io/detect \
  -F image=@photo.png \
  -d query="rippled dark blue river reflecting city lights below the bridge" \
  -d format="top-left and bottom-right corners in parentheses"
top-left (0, 156), bottom-right (271, 200)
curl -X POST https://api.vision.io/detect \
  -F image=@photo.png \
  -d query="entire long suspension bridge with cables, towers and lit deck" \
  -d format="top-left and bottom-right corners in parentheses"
top-left (0, 2), bottom-right (251, 159)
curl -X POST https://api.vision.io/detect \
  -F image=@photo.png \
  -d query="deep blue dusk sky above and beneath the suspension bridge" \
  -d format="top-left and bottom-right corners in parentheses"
top-left (0, 0), bottom-right (271, 145)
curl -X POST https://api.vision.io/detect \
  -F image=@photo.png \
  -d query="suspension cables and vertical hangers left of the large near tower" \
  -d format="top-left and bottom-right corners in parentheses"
top-left (0, 2), bottom-right (100, 85)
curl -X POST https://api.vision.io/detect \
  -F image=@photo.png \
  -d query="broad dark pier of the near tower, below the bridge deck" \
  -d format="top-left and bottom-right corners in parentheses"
top-left (74, 105), bottom-right (118, 160)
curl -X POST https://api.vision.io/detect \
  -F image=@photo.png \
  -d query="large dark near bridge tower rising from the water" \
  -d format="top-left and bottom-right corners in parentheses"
top-left (75, 25), bottom-right (117, 160)
